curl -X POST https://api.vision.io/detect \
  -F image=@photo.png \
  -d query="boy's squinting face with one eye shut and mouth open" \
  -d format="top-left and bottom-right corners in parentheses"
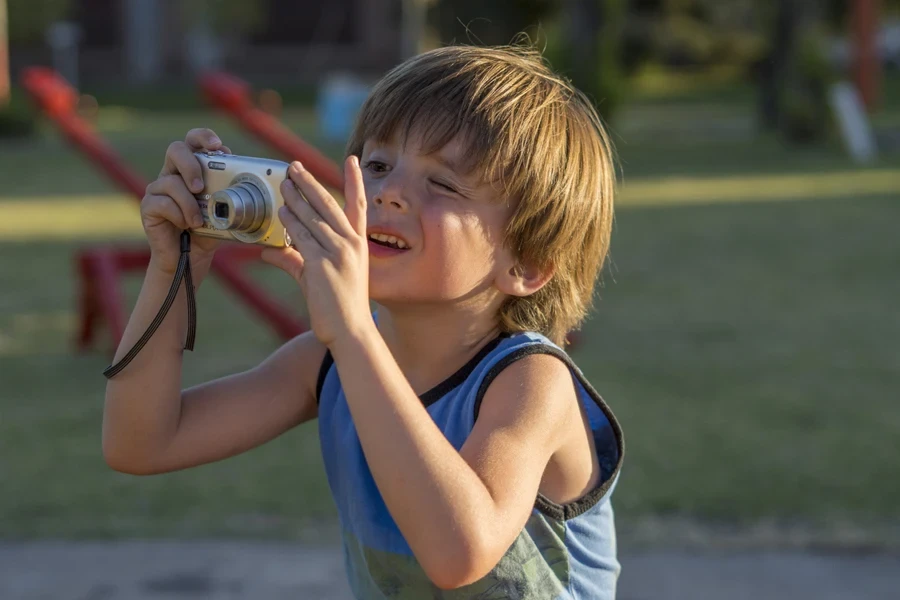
top-left (360, 132), bottom-right (515, 306)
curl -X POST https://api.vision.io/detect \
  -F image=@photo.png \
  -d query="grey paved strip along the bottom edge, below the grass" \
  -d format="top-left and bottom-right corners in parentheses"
top-left (0, 541), bottom-right (900, 600)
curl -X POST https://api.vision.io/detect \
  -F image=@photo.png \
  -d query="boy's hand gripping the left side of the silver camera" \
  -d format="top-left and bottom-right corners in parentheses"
top-left (141, 129), bottom-right (231, 274)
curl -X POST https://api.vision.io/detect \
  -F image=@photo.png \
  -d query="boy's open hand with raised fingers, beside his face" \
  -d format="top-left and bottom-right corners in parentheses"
top-left (262, 156), bottom-right (372, 346)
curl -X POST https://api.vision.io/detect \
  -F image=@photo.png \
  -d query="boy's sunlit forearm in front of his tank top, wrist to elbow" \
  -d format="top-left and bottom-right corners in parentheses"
top-left (331, 325), bottom-right (494, 571)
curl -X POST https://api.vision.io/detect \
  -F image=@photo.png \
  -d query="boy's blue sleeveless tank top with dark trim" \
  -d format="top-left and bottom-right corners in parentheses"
top-left (316, 333), bottom-right (624, 600)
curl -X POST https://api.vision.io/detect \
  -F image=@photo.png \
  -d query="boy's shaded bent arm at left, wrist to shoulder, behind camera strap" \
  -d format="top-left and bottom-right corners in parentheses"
top-left (103, 264), bottom-right (325, 475)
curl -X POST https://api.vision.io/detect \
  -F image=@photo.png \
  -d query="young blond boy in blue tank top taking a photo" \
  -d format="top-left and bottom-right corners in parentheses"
top-left (103, 47), bottom-right (624, 600)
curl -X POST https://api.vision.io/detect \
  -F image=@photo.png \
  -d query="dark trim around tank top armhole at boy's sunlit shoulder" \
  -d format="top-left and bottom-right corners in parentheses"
top-left (474, 342), bottom-right (625, 521)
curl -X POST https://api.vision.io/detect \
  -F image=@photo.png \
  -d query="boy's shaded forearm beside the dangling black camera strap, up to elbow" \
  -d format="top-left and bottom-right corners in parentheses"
top-left (103, 260), bottom-right (209, 466)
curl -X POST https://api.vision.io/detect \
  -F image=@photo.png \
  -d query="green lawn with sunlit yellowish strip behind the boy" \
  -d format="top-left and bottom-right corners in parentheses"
top-left (0, 91), bottom-right (900, 545)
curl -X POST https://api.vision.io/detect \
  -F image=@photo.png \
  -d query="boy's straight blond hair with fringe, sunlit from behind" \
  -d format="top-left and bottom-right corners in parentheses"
top-left (347, 46), bottom-right (615, 345)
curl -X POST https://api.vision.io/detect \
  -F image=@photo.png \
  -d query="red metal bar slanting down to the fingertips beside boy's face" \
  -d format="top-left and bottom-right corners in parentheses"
top-left (200, 73), bottom-right (344, 191)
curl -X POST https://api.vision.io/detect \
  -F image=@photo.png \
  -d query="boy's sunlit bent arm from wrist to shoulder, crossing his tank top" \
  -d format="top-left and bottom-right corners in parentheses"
top-left (331, 326), bottom-right (580, 589)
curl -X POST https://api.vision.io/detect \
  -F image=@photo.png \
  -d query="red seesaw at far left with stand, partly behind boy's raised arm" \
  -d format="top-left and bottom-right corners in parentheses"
top-left (22, 67), bottom-right (307, 348)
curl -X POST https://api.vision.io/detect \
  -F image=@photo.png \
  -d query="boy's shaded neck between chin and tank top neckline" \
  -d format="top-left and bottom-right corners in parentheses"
top-left (370, 305), bottom-right (500, 395)
